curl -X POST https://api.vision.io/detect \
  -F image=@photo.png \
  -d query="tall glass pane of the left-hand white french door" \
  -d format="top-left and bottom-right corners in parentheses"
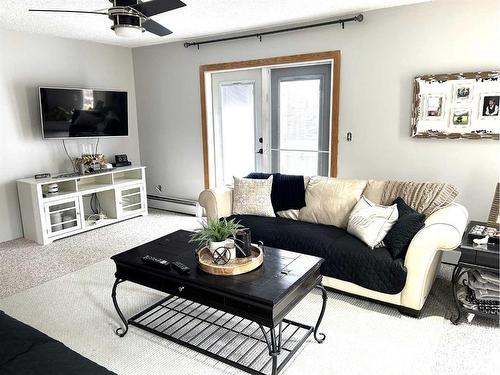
top-left (220, 83), bottom-right (256, 185)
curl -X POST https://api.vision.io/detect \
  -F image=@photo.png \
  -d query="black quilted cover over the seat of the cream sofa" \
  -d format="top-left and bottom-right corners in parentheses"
top-left (230, 215), bottom-right (406, 294)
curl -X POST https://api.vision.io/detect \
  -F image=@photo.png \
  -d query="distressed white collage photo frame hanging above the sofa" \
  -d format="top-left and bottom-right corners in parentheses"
top-left (411, 71), bottom-right (500, 140)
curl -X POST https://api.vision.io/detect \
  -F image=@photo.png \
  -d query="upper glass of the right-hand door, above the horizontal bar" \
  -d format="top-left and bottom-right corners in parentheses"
top-left (279, 79), bottom-right (321, 152)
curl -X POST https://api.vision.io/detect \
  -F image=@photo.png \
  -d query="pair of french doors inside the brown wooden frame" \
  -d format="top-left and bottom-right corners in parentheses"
top-left (211, 63), bottom-right (332, 186)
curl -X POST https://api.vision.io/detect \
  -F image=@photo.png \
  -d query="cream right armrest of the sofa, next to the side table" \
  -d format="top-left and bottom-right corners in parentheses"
top-left (401, 203), bottom-right (468, 310)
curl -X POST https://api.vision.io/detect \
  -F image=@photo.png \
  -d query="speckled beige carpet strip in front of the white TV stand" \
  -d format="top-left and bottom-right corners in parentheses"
top-left (0, 209), bottom-right (199, 298)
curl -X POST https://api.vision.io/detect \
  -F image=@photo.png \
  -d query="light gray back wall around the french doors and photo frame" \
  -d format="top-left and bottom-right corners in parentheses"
top-left (133, 0), bottom-right (500, 219)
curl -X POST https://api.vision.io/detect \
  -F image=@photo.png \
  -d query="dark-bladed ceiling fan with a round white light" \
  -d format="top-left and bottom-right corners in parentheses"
top-left (29, 0), bottom-right (186, 38)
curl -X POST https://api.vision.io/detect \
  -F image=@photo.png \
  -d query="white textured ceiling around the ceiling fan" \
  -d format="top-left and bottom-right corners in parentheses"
top-left (0, 0), bottom-right (431, 47)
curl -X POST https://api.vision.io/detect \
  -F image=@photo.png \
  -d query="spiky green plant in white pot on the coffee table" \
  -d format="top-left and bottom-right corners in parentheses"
top-left (189, 218), bottom-right (243, 259)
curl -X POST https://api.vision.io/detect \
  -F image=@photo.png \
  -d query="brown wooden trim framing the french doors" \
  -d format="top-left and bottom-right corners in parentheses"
top-left (199, 50), bottom-right (341, 189)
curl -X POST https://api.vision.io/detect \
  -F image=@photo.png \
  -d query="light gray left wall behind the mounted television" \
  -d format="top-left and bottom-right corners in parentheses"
top-left (0, 30), bottom-right (139, 242)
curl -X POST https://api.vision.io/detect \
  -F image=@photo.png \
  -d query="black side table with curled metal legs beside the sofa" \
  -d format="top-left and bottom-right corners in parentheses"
top-left (450, 221), bottom-right (500, 324)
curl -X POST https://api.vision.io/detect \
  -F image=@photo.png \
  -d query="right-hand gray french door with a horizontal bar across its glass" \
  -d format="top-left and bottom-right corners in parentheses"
top-left (270, 64), bottom-right (331, 176)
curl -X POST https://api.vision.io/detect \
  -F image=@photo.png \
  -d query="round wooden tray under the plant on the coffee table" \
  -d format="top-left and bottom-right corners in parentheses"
top-left (198, 245), bottom-right (264, 276)
